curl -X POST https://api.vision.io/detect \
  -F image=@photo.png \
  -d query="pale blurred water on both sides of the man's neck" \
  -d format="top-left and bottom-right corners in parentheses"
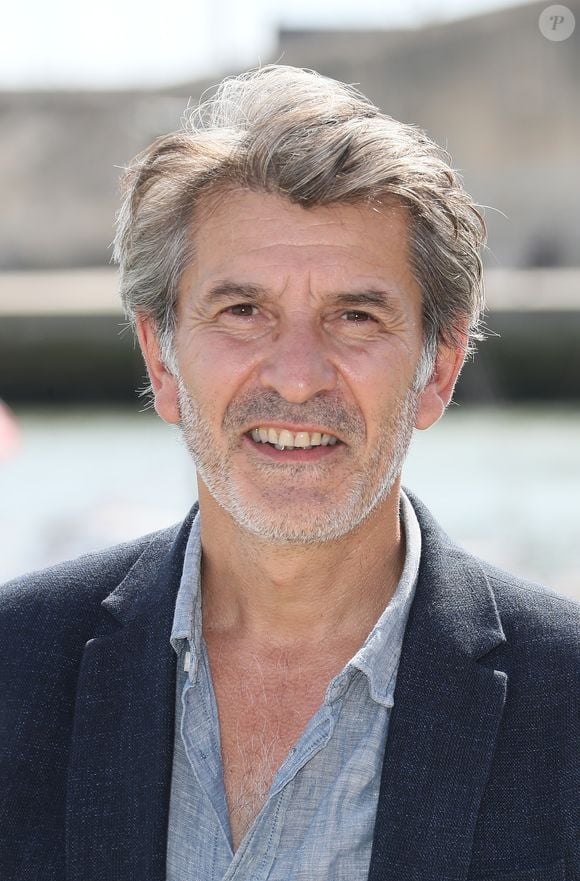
top-left (0, 406), bottom-right (580, 599)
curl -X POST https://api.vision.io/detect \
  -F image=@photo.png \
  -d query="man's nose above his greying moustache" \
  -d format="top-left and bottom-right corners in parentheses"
top-left (259, 313), bottom-right (336, 404)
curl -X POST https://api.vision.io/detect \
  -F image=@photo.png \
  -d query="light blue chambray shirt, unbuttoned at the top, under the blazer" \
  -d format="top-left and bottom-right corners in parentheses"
top-left (166, 492), bottom-right (421, 881)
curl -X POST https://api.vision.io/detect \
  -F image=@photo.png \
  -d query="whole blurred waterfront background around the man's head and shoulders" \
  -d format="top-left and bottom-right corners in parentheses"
top-left (0, 0), bottom-right (580, 599)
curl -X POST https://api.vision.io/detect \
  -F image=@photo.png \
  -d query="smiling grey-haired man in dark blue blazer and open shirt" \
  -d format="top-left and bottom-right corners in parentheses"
top-left (0, 66), bottom-right (580, 881)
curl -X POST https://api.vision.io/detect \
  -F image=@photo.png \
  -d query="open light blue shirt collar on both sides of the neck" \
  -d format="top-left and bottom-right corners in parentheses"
top-left (171, 490), bottom-right (421, 707)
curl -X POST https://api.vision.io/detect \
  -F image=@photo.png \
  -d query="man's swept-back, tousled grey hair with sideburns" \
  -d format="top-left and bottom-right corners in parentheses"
top-left (113, 64), bottom-right (486, 388)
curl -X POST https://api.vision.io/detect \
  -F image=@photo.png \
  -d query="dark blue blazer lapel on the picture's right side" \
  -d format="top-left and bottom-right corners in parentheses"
top-left (368, 490), bottom-right (507, 881)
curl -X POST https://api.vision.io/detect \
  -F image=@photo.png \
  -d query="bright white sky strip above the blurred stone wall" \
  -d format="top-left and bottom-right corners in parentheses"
top-left (0, 0), bottom-right (526, 89)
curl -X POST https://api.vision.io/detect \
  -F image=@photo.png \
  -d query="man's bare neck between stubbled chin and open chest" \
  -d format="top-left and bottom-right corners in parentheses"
top-left (199, 482), bottom-right (405, 646)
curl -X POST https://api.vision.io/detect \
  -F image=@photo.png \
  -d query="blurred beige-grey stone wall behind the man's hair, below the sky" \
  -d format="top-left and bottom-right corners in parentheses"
top-left (0, 0), bottom-right (580, 270)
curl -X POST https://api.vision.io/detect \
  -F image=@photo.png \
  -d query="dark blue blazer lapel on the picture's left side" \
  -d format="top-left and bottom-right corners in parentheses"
top-left (66, 504), bottom-right (198, 881)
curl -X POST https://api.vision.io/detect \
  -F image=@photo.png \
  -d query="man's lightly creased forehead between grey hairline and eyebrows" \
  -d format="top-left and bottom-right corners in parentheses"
top-left (181, 189), bottom-right (414, 300)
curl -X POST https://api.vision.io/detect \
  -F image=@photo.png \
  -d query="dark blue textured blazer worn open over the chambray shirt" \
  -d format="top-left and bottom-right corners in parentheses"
top-left (0, 491), bottom-right (580, 881)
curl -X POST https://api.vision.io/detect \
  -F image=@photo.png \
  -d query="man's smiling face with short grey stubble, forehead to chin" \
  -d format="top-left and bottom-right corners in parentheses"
top-left (158, 190), bottom-right (422, 544)
